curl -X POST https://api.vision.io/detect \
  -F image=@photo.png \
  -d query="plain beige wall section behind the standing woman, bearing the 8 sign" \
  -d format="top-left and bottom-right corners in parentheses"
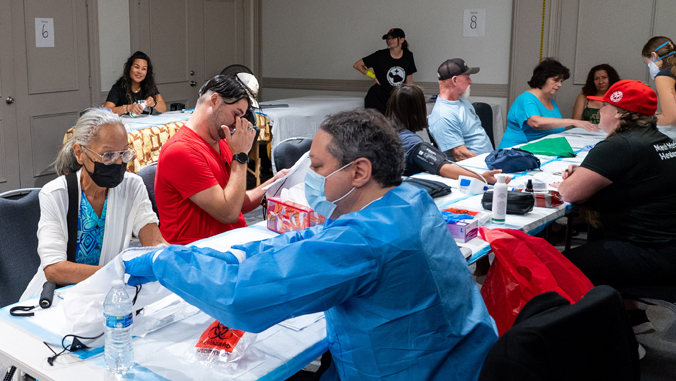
top-left (257, 0), bottom-right (512, 98)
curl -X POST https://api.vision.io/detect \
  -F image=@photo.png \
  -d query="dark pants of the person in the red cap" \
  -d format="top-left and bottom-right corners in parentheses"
top-left (563, 239), bottom-right (676, 286)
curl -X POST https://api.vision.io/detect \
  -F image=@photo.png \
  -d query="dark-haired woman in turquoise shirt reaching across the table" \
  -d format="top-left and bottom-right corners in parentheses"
top-left (498, 58), bottom-right (599, 149)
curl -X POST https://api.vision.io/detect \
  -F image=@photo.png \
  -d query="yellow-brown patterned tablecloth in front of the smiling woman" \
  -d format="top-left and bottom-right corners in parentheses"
top-left (63, 113), bottom-right (272, 173)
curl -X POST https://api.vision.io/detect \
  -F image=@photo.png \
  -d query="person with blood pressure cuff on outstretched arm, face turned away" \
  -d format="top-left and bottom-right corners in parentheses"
top-left (385, 85), bottom-right (502, 184)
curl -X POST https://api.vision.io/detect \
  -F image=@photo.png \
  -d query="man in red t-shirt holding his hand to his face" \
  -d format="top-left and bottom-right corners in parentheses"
top-left (155, 75), bottom-right (287, 244)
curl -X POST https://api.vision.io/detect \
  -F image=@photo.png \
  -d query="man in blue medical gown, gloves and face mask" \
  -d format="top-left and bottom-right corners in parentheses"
top-left (125, 110), bottom-right (497, 381)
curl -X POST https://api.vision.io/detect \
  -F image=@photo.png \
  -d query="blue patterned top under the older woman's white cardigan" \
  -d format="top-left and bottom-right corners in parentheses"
top-left (75, 191), bottom-right (108, 266)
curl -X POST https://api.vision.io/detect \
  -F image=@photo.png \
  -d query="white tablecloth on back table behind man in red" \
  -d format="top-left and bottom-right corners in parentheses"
top-left (261, 96), bottom-right (364, 149)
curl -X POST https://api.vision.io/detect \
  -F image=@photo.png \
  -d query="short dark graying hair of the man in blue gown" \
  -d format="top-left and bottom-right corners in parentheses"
top-left (319, 109), bottom-right (404, 187)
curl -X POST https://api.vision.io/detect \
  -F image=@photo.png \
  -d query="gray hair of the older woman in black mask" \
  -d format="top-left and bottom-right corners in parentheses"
top-left (54, 108), bottom-right (122, 176)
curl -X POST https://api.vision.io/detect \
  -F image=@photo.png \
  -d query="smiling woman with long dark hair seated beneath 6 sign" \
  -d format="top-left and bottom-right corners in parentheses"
top-left (103, 51), bottom-right (167, 115)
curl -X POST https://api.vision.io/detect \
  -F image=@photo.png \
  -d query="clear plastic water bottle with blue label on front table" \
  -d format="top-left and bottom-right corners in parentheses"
top-left (103, 279), bottom-right (134, 374)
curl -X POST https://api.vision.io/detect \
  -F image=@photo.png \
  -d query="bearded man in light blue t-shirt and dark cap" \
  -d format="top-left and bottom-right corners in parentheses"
top-left (429, 58), bottom-right (493, 161)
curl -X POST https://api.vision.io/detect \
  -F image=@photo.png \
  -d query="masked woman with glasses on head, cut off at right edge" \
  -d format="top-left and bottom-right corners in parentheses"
top-left (641, 36), bottom-right (676, 140)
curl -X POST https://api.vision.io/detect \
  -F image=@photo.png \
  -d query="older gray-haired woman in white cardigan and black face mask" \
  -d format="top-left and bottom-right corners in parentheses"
top-left (21, 109), bottom-right (166, 300)
